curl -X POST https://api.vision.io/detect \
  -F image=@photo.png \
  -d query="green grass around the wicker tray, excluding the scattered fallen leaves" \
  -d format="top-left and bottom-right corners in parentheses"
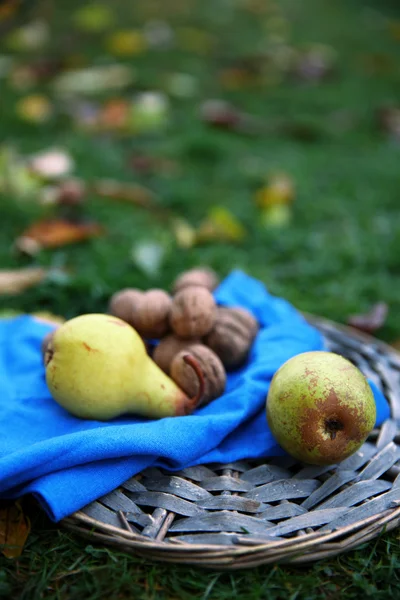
top-left (0, 0), bottom-right (400, 600)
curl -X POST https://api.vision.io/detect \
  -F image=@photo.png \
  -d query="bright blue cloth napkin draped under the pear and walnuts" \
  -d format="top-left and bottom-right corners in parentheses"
top-left (0, 271), bottom-right (389, 521)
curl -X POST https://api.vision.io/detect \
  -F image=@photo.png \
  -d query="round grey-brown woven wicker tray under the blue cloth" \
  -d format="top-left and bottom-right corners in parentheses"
top-left (62, 315), bottom-right (400, 569)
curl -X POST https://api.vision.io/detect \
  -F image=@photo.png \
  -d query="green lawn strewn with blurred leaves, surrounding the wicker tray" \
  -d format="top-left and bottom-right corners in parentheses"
top-left (0, 0), bottom-right (400, 600)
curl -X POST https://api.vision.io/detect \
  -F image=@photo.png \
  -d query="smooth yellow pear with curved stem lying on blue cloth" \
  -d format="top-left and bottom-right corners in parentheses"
top-left (45, 314), bottom-right (204, 421)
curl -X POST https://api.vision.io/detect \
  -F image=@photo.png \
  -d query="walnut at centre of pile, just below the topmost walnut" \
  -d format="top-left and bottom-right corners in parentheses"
top-left (170, 286), bottom-right (216, 338)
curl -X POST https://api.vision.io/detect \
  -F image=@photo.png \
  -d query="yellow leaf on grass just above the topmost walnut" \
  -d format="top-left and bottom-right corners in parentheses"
top-left (196, 206), bottom-right (246, 242)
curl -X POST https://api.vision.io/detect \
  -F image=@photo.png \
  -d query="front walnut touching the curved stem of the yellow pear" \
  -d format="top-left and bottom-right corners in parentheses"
top-left (170, 344), bottom-right (226, 406)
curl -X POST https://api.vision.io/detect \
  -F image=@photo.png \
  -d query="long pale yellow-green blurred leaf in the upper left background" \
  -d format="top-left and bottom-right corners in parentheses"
top-left (53, 64), bottom-right (134, 96)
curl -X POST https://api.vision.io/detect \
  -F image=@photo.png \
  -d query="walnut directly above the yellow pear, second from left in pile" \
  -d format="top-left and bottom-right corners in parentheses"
top-left (132, 289), bottom-right (172, 339)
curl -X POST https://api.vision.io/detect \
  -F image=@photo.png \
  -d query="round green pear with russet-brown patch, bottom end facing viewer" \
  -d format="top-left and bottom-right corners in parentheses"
top-left (266, 351), bottom-right (376, 465)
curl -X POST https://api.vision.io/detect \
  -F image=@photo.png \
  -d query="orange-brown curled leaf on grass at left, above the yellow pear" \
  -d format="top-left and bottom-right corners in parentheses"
top-left (15, 219), bottom-right (103, 255)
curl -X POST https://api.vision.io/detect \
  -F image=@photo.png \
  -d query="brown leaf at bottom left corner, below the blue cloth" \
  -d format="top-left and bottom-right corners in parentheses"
top-left (0, 500), bottom-right (31, 558)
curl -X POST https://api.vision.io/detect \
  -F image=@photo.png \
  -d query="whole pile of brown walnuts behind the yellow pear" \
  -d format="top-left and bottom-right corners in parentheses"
top-left (109, 268), bottom-right (259, 405)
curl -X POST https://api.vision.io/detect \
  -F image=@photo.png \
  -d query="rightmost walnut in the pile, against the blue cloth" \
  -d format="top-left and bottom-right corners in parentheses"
top-left (203, 306), bottom-right (258, 369)
